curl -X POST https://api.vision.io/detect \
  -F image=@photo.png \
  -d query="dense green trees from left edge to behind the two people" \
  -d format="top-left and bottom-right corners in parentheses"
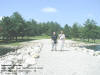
top-left (0, 12), bottom-right (61, 41)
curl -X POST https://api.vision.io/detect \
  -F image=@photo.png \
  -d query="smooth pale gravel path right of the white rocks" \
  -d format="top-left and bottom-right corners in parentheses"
top-left (35, 39), bottom-right (100, 75)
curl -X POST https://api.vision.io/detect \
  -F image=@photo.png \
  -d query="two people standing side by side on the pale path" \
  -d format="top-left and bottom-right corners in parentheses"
top-left (51, 31), bottom-right (65, 51)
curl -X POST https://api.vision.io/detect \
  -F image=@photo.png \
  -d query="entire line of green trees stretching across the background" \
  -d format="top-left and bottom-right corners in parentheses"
top-left (0, 12), bottom-right (100, 42)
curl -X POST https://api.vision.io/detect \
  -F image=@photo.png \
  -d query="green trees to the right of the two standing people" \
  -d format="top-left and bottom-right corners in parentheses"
top-left (64, 19), bottom-right (100, 42)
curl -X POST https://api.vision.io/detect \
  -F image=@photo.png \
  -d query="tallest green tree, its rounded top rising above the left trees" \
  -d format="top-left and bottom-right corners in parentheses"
top-left (10, 12), bottom-right (25, 41)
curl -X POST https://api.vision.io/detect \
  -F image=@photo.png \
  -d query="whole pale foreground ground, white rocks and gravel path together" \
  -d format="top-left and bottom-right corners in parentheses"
top-left (0, 39), bottom-right (100, 75)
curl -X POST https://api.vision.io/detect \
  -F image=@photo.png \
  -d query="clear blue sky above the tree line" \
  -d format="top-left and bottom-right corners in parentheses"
top-left (0, 0), bottom-right (100, 26)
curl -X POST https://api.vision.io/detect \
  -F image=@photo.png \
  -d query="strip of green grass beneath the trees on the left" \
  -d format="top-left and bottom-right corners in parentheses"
top-left (0, 35), bottom-right (50, 47)
